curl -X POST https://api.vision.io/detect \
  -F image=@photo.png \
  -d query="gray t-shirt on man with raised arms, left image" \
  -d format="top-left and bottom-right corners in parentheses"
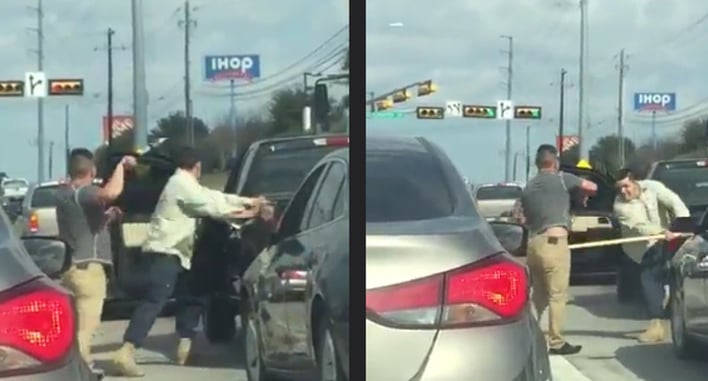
top-left (56, 184), bottom-right (113, 264)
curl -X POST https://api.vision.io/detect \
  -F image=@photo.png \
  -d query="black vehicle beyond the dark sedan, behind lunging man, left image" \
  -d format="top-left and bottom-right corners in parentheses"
top-left (192, 134), bottom-right (349, 342)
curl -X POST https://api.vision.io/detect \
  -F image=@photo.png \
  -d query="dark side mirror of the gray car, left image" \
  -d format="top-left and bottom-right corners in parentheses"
top-left (22, 237), bottom-right (72, 278)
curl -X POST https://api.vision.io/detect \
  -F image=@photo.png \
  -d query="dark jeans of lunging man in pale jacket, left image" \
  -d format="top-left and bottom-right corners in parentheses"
top-left (123, 253), bottom-right (203, 348)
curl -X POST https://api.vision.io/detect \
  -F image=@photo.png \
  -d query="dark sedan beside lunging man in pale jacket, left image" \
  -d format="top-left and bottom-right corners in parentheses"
top-left (241, 149), bottom-right (350, 381)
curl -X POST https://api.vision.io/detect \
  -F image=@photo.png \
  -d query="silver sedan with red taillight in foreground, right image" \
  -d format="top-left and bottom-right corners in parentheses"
top-left (365, 137), bottom-right (551, 381)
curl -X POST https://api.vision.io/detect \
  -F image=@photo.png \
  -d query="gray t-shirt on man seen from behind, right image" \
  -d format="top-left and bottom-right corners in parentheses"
top-left (521, 172), bottom-right (583, 235)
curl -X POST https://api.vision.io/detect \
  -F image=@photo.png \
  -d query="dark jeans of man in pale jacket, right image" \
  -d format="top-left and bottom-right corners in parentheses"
top-left (639, 243), bottom-right (668, 319)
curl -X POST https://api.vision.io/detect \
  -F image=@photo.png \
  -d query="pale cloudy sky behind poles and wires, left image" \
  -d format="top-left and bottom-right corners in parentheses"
top-left (0, 0), bottom-right (349, 180)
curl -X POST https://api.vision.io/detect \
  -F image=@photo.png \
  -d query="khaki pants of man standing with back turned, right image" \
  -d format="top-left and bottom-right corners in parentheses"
top-left (527, 234), bottom-right (570, 348)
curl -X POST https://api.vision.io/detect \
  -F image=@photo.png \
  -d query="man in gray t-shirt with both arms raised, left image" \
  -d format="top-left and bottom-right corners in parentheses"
top-left (56, 148), bottom-right (135, 365)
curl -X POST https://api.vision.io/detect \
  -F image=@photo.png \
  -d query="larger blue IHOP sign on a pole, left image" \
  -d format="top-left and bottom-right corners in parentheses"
top-left (204, 54), bottom-right (261, 81)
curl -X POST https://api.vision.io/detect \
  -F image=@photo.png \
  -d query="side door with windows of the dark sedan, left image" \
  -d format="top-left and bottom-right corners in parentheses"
top-left (280, 159), bottom-right (347, 368)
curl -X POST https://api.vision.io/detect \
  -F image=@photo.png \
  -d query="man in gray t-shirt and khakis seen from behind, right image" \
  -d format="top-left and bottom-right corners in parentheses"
top-left (519, 144), bottom-right (597, 355)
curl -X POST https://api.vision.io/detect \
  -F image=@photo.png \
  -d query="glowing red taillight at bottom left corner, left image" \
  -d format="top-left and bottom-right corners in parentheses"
top-left (0, 283), bottom-right (76, 372)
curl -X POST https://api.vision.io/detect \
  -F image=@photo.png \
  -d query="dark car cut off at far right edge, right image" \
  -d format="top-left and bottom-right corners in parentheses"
top-left (669, 213), bottom-right (708, 359)
